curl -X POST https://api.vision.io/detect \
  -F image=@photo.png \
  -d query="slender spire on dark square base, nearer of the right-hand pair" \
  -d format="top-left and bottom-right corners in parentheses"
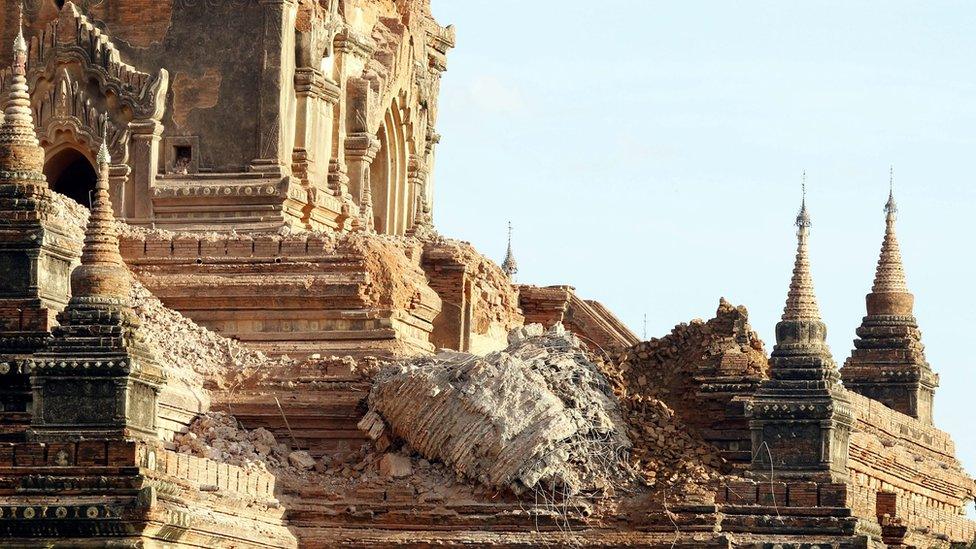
top-left (750, 175), bottom-right (853, 482)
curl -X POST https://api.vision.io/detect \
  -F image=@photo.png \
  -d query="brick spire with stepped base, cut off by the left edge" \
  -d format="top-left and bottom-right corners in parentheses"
top-left (0, 7), bottom-right (83, 439)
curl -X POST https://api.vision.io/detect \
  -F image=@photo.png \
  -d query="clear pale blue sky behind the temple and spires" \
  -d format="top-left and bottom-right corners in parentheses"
top-left (433, 0), bottom-right (976, 488)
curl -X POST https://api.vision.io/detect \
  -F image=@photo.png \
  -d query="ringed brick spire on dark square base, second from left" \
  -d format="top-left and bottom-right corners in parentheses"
top-left (29, 137), bottom-right (165, 441)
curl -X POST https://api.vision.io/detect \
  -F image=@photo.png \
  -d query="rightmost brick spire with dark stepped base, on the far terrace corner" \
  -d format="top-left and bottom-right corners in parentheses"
top-left (841, 176), bottom-right (939, 424)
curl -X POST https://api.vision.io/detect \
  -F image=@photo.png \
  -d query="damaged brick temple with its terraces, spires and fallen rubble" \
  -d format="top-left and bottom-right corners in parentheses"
top-left (0, 0), bottom-right (976, 549)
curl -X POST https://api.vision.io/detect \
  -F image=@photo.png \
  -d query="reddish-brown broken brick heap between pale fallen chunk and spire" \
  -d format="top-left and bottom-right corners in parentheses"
top-left (595, 299), bottom-right (769, 493)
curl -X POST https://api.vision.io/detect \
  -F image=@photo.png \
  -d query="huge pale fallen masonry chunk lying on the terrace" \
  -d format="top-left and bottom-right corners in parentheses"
top-left (360, 325), bottom-right (631, 497)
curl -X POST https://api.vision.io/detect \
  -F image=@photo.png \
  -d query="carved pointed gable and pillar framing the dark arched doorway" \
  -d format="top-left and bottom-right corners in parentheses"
top-left (27, 4), bottom-right (169, 222)
